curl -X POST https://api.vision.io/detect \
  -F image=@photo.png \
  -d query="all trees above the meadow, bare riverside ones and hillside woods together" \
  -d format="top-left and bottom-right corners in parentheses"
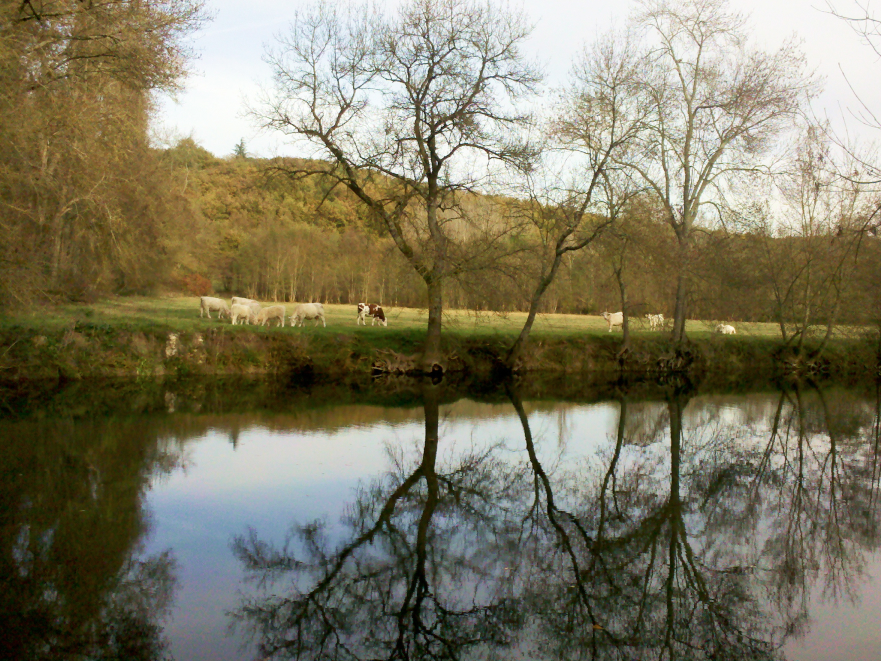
top-left (0, 0), bottom-right (881, 372)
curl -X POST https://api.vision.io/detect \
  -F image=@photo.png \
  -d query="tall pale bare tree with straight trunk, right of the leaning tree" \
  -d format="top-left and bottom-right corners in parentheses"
top-left (626, 0), bottom-right (812, 345)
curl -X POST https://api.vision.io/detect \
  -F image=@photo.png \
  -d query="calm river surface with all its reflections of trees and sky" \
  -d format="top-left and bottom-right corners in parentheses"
top-left (0, 383), bottom-right (881, 660)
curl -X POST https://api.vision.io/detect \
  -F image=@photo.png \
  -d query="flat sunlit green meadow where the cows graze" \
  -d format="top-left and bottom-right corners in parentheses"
top-left (0, 296), bottom-right (844, 339)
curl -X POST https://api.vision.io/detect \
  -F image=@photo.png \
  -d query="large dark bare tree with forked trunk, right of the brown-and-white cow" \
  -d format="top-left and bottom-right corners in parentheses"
top-left (255, 0), bottom-right (539, 371)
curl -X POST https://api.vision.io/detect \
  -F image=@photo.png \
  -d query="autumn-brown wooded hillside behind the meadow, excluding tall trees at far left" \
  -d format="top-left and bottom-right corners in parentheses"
top-left (146, 139), bottom-right (881, 323)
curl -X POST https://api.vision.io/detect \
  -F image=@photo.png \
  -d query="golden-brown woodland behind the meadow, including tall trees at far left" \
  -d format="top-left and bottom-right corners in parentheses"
top-left (0, 0), bottom-right (881, 338)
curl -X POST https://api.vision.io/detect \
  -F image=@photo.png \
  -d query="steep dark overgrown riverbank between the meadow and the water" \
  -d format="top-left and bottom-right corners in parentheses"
top-left (0, 320), bottom-right (878, 382)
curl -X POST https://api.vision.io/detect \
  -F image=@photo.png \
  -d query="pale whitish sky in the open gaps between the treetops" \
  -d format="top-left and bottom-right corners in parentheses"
top-left (155, 0), bottom-right (881, 156)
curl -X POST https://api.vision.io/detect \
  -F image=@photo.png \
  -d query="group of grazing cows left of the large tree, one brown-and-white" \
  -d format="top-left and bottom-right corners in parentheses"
top-left (199, 296), bottom-right (388, 327)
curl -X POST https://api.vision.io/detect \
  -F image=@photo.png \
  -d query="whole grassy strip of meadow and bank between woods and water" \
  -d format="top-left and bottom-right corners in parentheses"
top-left (0, 297), bottom-right (877, 380)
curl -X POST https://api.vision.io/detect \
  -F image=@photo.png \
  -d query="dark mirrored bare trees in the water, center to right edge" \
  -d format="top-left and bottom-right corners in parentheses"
top-left (233, 383), bottom-right (881, 661)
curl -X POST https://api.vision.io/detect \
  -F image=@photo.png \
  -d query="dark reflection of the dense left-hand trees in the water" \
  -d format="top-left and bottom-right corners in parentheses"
top-left (0, 417), bottom-right (176, 661)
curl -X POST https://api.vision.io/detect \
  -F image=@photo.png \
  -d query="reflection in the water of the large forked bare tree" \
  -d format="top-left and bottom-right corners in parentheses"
top-left (234, 382), bottom-right (523, 659)
